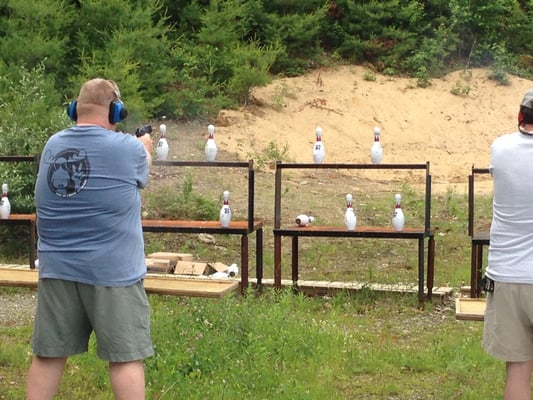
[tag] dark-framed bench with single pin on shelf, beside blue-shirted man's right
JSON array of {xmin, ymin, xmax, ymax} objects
[{"xmin": 142, "ymin": 160, "xmax": 263, "ymax": 293}]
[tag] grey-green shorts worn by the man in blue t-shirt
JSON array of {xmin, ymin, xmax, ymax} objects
[{"xmin": 32, "ymin": 279, "xmax": 154, "ymax": 362}]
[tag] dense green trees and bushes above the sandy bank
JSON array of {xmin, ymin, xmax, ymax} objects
[{"xmin": 0, "ymin": 0, "xmax": 533, "ymax": 212}]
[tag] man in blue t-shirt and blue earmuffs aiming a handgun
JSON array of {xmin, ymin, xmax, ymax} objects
[{"xmin": 27, "ymin": 78, "xmax": 153, "ymax": 400}]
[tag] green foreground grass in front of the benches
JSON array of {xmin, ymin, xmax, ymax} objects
[{"xmin": 0, "ymin": 290, "xmax": 504, "ymax": 400}]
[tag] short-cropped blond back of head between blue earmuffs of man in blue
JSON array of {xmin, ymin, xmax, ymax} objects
[{"xmin": 76, "ymin": 78, "xmax": 120, "ymax": 117}]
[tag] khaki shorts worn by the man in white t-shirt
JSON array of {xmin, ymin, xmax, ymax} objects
[{"xmin": 483, "ymin": 282, "xmax": 533, "ymax": 362}]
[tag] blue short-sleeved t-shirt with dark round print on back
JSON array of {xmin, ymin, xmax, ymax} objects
[{"xmin": 35, "ymin": 126, "xmax": 149, "ymax": 286}]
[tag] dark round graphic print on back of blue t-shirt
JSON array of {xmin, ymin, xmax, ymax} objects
[{"xmin": 45, "ymin": 149, "xmax": 91, "ymax": 197}]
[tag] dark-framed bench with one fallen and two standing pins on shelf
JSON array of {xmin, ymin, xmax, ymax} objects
[{"xmin": 274, "ymin": 161, "xmax": 435, "ymax": 304}]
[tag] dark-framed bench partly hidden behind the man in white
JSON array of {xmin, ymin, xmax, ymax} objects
[{"xmin": 468, "ymin": 165, "xmax": 490, "ymax": 298}]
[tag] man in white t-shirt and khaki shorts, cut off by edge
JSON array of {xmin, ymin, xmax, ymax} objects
[{"xmin": 483, "ymin": 88, "xmax": 533, "ymax": 400}]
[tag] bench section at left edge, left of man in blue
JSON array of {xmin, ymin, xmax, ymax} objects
[{"xmin": 0, "ymin": 154, "xmax": 40, "ymax": 269}]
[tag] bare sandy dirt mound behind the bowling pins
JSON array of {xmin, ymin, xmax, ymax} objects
[{"xmin": 212, "ymin": 66, "xmax": 533, "ymax": 192}]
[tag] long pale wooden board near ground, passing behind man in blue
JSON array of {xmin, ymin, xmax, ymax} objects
[{"xmin": 0, "ymin": 268, "xmax": 239, "ymax": 298}]
